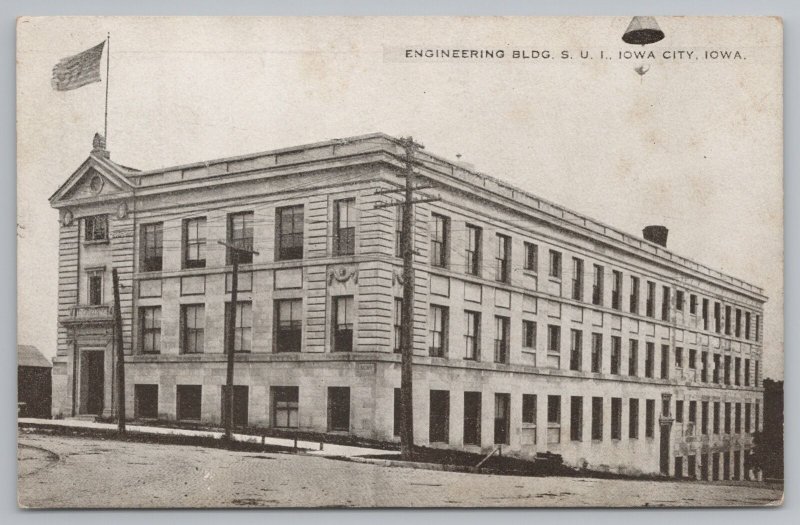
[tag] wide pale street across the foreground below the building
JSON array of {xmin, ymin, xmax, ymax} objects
[{"xmin": 17, "ymin": 433, "xmax": 783, "ymax": 508}]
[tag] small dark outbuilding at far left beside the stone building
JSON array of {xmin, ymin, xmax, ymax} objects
[{"xmin": 17, "ymin": 345, "xmax": 53, "ymax": 418}]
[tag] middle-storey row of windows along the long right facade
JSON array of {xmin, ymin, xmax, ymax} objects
[{"xmin": 422, "ymin": 299, "xmax": 759, "ymax": 386}]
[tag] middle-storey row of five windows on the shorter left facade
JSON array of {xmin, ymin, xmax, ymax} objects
[{"xmin": 139, "ymin": 296, "xmax": 355, "ymax": 354}]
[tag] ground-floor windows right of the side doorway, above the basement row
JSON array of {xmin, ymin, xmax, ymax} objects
[{"xmin": 675, "ymin": 399, "xmax": 761, "ymax": 436}]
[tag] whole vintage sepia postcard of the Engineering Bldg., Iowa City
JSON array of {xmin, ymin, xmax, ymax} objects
[{"xmin": 17, "ymin": 17, "xmax": 784, "ymax": 508}]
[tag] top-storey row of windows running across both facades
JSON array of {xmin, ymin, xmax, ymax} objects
[{"xmin": 85, "ymin": 207, "xmax": 760, "ymax": 341}]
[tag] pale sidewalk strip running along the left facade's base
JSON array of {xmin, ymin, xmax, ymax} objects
[{"xmin": 17, "ymin": 417, "xmax": 400, "ymax": 458}]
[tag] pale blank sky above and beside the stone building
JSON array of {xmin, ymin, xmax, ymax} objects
[{"xmin": 17, "ymin": 17, "xmax": 783, "ymax": 379}]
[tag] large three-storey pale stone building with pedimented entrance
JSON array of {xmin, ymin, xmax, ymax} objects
[{"xmin": 51, "ymin": 134, "xmax": 766, "ymax": 479}]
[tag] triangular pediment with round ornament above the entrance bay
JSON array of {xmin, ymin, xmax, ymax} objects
[{"xmin": 50, "ymin": 155, "xmax": 133, "ymax": 205}]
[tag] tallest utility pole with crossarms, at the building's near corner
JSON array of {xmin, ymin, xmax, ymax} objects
[{"xmin": 375, "ymin": 137, "xmax": 439, "ymax": 460}]
